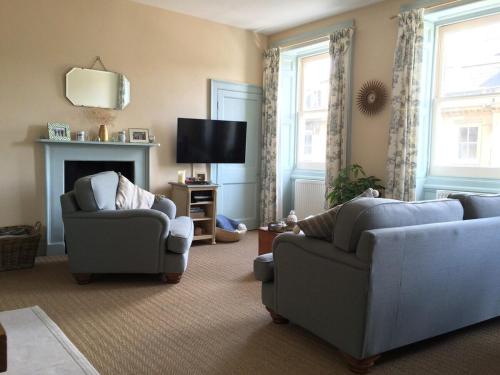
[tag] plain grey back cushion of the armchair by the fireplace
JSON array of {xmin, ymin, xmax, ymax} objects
[{"xmin": 74, "ymin": 172, "xmax": 118, "ymax": 212}]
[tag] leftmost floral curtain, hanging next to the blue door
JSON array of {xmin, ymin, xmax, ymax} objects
[{"xmin": 260, "ymin": 48, "xmax": 280, "ymax": 225}]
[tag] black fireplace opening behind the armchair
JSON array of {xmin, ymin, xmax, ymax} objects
[{"xmin": 64, "ymin": 160, "xmax": 135, "ymax": 193}]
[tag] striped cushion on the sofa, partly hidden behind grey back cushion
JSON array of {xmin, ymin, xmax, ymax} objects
[{"xmin": 297, "ymin": 188, "xmax": 379, "ymax": 242}]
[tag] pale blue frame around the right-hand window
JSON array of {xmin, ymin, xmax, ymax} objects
[{"xmin": 418, "ymin": 0, "xmax": 500, "ymax": 200}]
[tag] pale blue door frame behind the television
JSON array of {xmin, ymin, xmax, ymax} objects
[{"xmin": 209, "ymin": 79, "xmax": 263, "ymax": 225}]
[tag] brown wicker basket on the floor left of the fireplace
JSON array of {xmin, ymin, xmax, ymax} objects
[{"xmin": 0, "ymin": 222, "xmax": 40, "ymax": 271}]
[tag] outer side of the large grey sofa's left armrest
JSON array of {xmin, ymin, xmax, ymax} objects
[{"xmin": 266, "ymin": 234, "xmax": 370, "ymax": 358}]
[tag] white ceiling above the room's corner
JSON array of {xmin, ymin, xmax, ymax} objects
[{"xmin": 133, "ymin": 0, "xmax": 382, "ymax": 35}]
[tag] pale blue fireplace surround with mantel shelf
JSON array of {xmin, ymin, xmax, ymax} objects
[{"xmin": 37, "ymin": 139, "xmax": 159, "ymax": 255}]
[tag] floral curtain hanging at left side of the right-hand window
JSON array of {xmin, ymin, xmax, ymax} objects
[{"xmin": 385, "ymin": 9, "xmax": 424, "ymax": 201}]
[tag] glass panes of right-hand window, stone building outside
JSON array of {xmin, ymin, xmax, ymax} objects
[{"xmin": 431, "ymin": 15, "xmax": 500, "ymax": 178}]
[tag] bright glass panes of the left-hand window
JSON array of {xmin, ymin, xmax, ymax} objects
[{"xmin": 296, "ymin": 53, "xmax": 330, "ymax": 170}]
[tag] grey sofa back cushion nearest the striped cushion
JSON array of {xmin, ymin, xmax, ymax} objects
[{"xmin": 333, "ymin": 198, "xmax": 463, "ymax": 252}]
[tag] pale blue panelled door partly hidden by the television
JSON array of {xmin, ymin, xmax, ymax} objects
[{"xmin": 211, "ymin": 80, "xmax": 262, "ymax": 229}]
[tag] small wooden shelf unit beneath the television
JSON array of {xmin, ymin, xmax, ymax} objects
[{"xmin": 169, "ymin": 182, "xmax": 219, "ymax": 245}]
